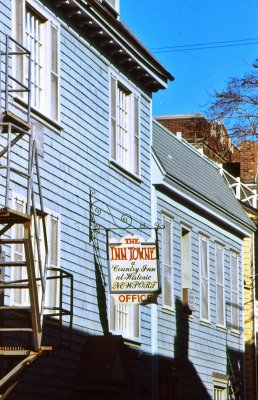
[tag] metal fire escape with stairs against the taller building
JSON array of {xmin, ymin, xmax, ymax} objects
[{"xmin": 0, "ymin": 36, "xmax": 72, "ymax": 399}]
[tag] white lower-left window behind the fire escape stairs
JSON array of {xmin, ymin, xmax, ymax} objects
[{"xmin": 11, "ymin": 196, "xmax": 60, "ymax": 307}]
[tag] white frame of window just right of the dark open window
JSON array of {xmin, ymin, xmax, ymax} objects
[{"xmin": 199, "ymin": 234, "xmax": 210, "ymax": 322}]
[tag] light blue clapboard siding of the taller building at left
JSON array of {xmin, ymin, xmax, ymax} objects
[{"xmin": 0, "ymin": 1, "xmax": 155, "ymax": 400}]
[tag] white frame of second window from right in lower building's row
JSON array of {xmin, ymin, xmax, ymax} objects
[{"xmin": 215, "ymin": 243, "xmax": 226, "ymax": 328}]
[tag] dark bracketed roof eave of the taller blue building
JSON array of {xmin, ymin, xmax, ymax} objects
[{"xmin": 51, "ymin": 0, "xmax": 174, "ymax": 92}]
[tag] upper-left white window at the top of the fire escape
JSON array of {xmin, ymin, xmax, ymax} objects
[{"xmin": 12, "ymin": 0, "xmax": 59, "ymax": 120}]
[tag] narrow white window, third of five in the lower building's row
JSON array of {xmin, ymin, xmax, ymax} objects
[{"xmin": 199, "ymin": 236, "xmax": 210, "ymax": 320}]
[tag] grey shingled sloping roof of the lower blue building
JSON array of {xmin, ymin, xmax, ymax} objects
[{"xmin": 153, "ymin": 120, "xmax": 255, "ymax": 235}]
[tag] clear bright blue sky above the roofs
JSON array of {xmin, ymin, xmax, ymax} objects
[{"xmin": 120, "ymin": 0, "xmax": 258, "ymax": 119}]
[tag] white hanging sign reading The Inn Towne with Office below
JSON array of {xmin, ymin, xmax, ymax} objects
[{"xmin": 109, "ymin": 236, "xmax": 160, "ymax": 304}]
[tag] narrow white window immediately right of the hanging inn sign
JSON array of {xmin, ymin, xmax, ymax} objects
[{"xmin": 162, "ymin": 215, "xmax": 173, "ymax": 308}]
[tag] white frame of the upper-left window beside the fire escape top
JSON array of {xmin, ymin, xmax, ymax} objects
[{"xmin": 12, "ymin": 0, "xmax": 60, "ymax": 122}]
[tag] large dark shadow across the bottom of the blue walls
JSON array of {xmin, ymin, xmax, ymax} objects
[{"xmin": 3, "ymin": 300, "xmax": 246, "ymax": 400}]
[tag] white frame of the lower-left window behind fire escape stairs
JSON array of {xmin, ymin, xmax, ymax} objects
[{"xmin": 10, "ymin": 193, "xmax": 61, "ymax": 313}]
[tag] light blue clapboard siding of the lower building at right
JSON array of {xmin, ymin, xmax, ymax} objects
[{"xmin": 157, "ymin": 192, "xmax": 243, "ymax": 395}]
